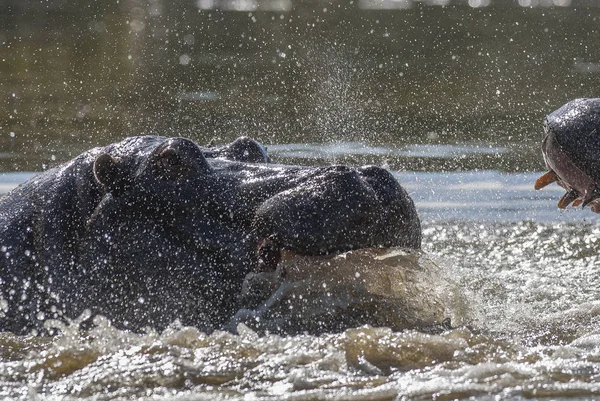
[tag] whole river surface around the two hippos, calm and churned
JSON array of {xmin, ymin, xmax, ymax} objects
[{"xmin": 0, "ymin": 0, "xmax": 600, "ymax": 401}]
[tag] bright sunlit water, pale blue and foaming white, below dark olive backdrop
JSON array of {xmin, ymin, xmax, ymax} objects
[{"xmin": 0, "ymin": 143, "xmax": 600, "ymax": 400}]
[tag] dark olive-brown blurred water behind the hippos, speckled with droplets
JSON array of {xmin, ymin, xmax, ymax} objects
[{"xmin": 0, "ymin": 0, "xmax": 600, "ymax": 172}]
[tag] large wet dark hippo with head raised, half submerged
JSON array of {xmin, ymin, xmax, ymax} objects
[{"xmin": 0, "ymin": 136, "xmax": 421, "ymax": 334}]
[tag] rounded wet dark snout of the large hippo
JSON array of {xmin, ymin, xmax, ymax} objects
[{"xmin": 253, "ymin": 166, "xmax": 421, "ymax": 255}]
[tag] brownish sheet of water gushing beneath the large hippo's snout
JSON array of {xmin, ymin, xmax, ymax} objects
[{"xmin": 232, "ymin": 248, "xmax": 470, "ymax": 334}]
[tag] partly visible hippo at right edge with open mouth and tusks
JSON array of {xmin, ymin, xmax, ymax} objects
[{"xmin": 535, "ymin": 99, "xmax": 600, "ymax": 213}]
